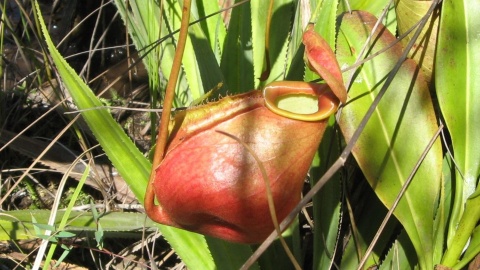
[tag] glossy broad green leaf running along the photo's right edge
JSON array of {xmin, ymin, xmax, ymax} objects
[{"xmin": 435, "ymin": 0, "xmax": 480, "ymax": 266}]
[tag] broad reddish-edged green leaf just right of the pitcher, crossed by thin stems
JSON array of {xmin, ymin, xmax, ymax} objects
[{"xmin": 337, "ymin": 12, "xmax": 442, "ymax": 269}]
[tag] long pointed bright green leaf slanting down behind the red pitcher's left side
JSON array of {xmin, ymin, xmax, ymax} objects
[{"xmin": 35, "ymin": 2, "xmax": 214, "ymax": 269}]
